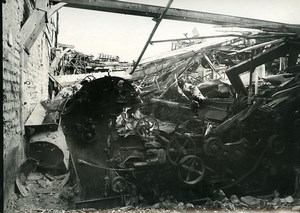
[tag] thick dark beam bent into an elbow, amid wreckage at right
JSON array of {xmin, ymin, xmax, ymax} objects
[{"xmin": 226, "ymin": 44, "xmax": 288, "ymax": 95}]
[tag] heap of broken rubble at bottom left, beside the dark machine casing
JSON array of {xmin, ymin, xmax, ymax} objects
[{"xmin": 7, "ymin": 172, "xmax": 76, "ymax": 212}]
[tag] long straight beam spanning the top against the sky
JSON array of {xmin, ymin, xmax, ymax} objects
[{"xmin": 50, "ymin": 0, "xmax": 300, "ymax": 33}]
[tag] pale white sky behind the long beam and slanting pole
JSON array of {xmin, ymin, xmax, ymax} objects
[{"xmin": 58, "ymin": 0, "xmax": 300, "ymax": 62}]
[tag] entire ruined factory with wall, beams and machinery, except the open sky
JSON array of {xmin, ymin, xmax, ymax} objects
[{"xmin": 2, "ymin": 0, "xmax": 300, "ymax": 212}]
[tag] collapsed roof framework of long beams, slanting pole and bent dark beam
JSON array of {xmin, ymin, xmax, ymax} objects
[{"xmin": 50, "ymin": 0, "xmax": 300, "ymax": 94}]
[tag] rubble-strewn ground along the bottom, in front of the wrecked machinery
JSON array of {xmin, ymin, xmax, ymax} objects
[{"xmin": 6, "ymin": 172, "xmax": 300, "ymax": 213}]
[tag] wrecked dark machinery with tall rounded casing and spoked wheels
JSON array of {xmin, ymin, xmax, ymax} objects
[{"xmin": 61, "ymin": 76, "xmax": 300, "ymax": 206}]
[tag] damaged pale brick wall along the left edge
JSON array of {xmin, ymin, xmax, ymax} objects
[{"xmin": 2, "ymin": 0, "xmax": 56, "ymax": 206}]
